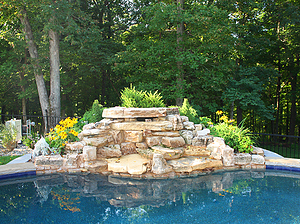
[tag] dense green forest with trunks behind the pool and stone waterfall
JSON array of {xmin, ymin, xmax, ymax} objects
[{"xmin": 0, "ymin": 0, "xmax": 300, "ymax": 135}]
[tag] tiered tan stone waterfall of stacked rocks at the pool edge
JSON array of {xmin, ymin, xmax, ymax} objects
[{"xmin": 35, "ymin": 107, "xmax": 265, "ymax": 178}]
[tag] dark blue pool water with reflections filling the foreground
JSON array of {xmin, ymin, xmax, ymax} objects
[{"xmin": 0, "ymin": 171, "xmax": 300, "ymax": 224}]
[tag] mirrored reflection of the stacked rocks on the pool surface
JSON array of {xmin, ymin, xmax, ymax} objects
[{"xmin": 34, "ymin": 171, "xmax": 258, "ymax": 208}]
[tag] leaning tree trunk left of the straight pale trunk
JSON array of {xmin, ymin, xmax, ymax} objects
[{"xmin": 20, "ymin": 8, "xmax": 49, "ymax": 131}]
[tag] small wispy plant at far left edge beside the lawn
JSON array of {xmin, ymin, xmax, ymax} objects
[{"xmin": 0, "ymin": 124, "xmax": 17, "ymax": 150}]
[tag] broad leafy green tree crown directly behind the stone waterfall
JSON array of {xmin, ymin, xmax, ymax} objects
[{"xmin": 113, "ymin": 1, "xmax": 233, "ymax": 107}]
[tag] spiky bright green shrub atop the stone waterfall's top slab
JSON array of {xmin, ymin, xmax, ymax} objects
[{"xmin": 121, "ymin": 86, "xmax": 165, "ymax": 108}]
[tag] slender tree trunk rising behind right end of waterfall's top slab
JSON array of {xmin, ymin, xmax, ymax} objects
[{"xmin": 176, "ymin": 0, "xmax": 184, "ymax": 106}]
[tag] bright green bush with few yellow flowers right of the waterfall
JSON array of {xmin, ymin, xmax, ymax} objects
[{"xmin": 211, "ymin": 111, "xmax": 255, "ymax": 153}]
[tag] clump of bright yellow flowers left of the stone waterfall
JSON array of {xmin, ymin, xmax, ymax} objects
[{"xmin": 45, "ymin": 117, "xmax": 82, "ymax": 154}]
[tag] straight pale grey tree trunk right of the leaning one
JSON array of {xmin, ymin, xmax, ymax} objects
[{"xmin": 49, "ymin": 29, "xmax": 61, "ymax": 127}]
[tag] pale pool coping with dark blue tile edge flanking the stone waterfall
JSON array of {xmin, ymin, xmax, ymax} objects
[{"xmin": 0, "ymin": 150, "xmax": 300, "ymax": 180}]
